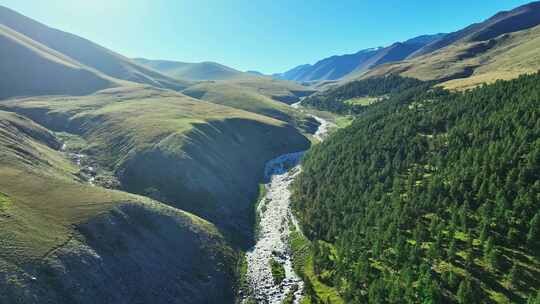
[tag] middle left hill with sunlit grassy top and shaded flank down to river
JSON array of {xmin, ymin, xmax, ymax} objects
[{"xmin": 0, "ymin": 87, "xmax": 309, "ymax": 243}]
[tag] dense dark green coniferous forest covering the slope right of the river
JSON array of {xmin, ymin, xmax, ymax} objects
[{"xmin": 293, "ymin": 73, "xmax": 540, "ymax": 304}]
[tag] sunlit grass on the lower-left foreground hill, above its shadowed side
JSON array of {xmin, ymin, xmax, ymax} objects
[{"xmin": 0, "ymin": 111, "xmax": 221, "ymax": 271}]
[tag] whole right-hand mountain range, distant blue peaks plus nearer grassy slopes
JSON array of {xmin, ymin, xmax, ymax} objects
[{"xmin": 273, "ymin": 1, "xmax": 540, "ymax": 87}]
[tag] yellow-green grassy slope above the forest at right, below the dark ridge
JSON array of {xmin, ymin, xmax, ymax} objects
[{"xmin": 364, "ymin": 26, "xmax": 540, "ymax": 89}]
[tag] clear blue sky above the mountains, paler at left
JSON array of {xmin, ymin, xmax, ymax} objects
[{"xmin": 0, "ymin": 0, "xmax": 529, "ymax": 73}]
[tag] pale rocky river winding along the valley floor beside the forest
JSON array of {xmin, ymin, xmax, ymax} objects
[{"xmin": 246, "ymin": 116, "xmax": 332, "ymax": 304}]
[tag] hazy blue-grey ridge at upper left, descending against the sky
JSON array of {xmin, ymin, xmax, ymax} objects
[{"xmin": 0, "ymin": 6, "xmax": 188, "ymax": 94}]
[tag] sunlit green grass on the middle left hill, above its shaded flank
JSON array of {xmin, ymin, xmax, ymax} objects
[{"xmin": 4, "ymin": 87, "xmax": 284, "ymax": 167}]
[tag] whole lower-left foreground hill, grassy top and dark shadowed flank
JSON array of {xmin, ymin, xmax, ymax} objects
[{"xmin": 0, "ymin": 111, "xmax": 233, "ymax": 303}]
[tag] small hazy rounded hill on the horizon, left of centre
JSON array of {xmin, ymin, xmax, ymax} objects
[{"xmin": 134, "ymin": 58, "xmax": 246, "ymax": 81}]
